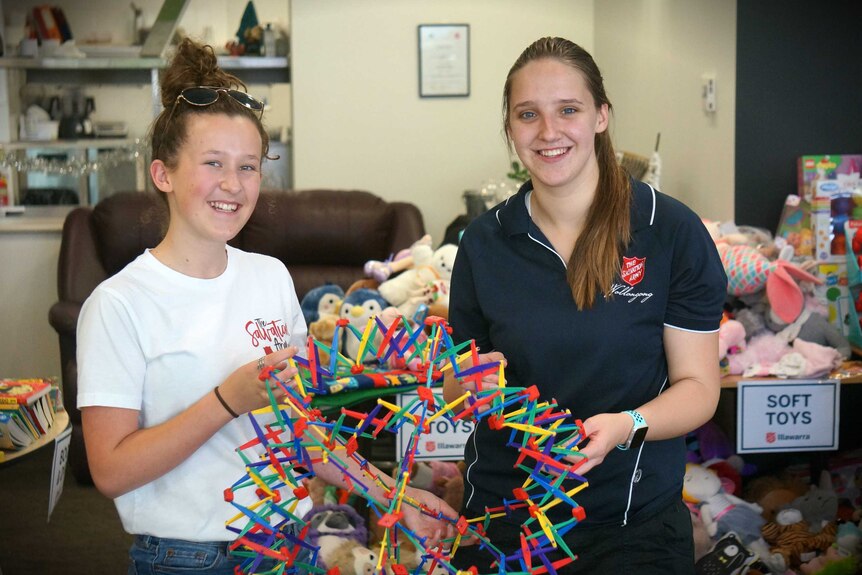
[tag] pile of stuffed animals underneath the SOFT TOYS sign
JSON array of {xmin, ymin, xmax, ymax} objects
[{"xmin": 696, "ymin": 464, "xmax": 862, "ymax": 575}]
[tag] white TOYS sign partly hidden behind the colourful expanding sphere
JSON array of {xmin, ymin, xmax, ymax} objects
[{"xmin": 395, "ymin": 389, "xmax": 476, "ymax": 461}]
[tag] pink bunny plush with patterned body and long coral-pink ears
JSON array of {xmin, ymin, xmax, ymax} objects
[{"xmin": 716, "ymin": 242, "xmax": 823, "ymax": 323}]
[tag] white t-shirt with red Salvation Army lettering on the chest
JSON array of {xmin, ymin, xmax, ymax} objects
[{"xmin": 77, "ymin": 246, "xmax": 311, "ymax": 541}]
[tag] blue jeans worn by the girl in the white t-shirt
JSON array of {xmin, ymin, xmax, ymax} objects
[{"xmin": 128, "ymin": 535, "xmax": 318, "ymax": 575}]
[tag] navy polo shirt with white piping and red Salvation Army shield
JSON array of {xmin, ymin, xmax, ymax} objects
[{"xmin": 449, "ymin": 181, "xmax": 727, "ymax": 527}]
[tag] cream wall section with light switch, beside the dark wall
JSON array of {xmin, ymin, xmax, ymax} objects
[{"xmin": 594, "ymin": 0, "xmax": 736, "ymax": 220}]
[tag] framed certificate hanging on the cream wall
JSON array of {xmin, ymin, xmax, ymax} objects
[{"xmin": 418, "ymin": 24, "xmax": 470, "ymax": 98}]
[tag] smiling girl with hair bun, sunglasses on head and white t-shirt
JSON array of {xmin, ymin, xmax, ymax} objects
[{"xmin": 78, "ymin": 40, "xmax": 455, "ymax": 575}]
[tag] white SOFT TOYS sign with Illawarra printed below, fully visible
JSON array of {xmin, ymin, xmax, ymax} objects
[{"xmin": 736, "ymin": 380, "xmax": 841, "ymax": 453}]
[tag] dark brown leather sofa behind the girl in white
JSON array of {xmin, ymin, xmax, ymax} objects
[{"xmin": 48, "ymin": 190, "xmax": 425, "ymax": 483}]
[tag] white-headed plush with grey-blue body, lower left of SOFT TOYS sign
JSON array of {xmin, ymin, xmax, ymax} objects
[{"xmin": 682, "ymin": 463, "xmax": 787, "ymax": 573}]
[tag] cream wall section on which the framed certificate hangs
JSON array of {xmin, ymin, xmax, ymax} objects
[{"xmin": 291, "ymin": 0, "xmax": 598, "ymax": 241}]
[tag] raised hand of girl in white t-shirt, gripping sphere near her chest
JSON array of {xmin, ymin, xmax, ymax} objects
[{"xmin": 218, "ymin": 346, "xmax": 298, "ymax": 414}]
